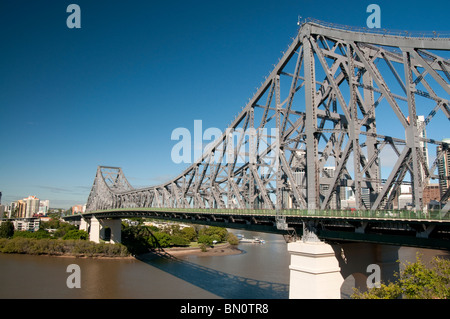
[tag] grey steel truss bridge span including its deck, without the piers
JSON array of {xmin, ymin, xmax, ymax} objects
[{"xmin": 66, "ymin": 21, "xmax": 450, "ymax": 248}]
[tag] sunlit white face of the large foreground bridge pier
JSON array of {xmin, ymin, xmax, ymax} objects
[{"xmin": 288, "ymin": 236, "xmax": 344, "ymax": 299}]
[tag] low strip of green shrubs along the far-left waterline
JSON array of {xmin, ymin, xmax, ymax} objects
[{"xmin": 0, "ymin": 237, "xmax": 130, "ymax": 257}]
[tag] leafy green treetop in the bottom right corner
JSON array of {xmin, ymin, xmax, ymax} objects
[{"xmin": 352, "ymin": 254, "xmax": 450, "ymax": 299}]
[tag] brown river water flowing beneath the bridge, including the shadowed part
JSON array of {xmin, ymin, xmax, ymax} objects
[{"xmin": 0, "ymin": 230, "xmax": 449, "ymax": 299}]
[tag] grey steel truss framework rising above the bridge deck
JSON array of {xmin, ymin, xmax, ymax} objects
[{"xmin": 87, "ymin": 23, "xmax": 450, "ymax": 211}]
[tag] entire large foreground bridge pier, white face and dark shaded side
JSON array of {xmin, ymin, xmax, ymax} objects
[{"xmin": 288, "ymin": 223, "xmax": 400, "ymax": 299}]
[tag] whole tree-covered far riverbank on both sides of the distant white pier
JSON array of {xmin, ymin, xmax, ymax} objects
[{"xmin": 0, "ymin": 220, "xmax": 239, "ymax": 257}]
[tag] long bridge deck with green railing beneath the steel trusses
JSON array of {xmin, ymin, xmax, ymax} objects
[{"xmin": 64, "ymin": 207, "xmax": 450, "ymax": 249}]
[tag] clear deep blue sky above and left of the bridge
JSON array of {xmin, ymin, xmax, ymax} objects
[{"xmin": 0, "ymin": 0, "xmax": 450, "ymax": 208}]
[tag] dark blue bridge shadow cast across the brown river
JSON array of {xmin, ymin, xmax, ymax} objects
[{"xmin": 136, "ymin": 250, "xmax": 289, "ymax": 299}]
